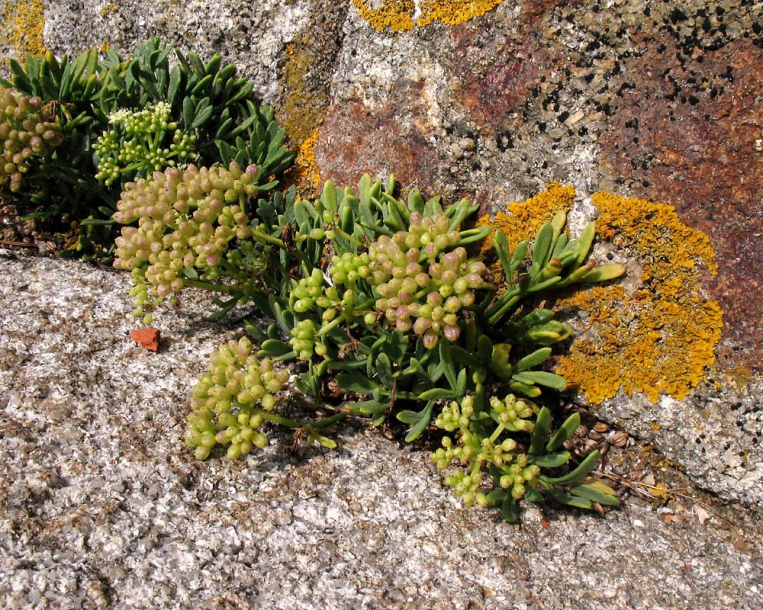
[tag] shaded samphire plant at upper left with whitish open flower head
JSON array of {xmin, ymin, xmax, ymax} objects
[{"xmin": 0, "ymin": 38, "xmax": 294, "ymax": 256}]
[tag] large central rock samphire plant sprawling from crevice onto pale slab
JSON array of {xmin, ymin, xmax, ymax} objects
[{"xmin": 115, "ymin": 167, "xmax": 624, "ymax": 521}]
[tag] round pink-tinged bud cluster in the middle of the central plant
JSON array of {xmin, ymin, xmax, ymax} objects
[{"xmin": 360, "ymin": 212, "xmax": 487, "ymax": 349}]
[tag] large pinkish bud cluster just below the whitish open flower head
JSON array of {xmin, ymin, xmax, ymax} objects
[{"xmin": 114, "ymin": 162, "xmax": 258, "ymax": 300}]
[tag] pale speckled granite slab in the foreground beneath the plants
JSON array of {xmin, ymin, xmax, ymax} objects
[{"xmin": 0, "ymin": 258, "xmax": 763, "ymax": 610}]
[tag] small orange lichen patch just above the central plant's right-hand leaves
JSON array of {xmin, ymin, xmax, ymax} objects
[{"xmin": 476, "ymin": 182, "xmax": 575, "ymax": 252}]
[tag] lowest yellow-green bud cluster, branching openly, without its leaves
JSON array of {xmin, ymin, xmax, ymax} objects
[{"xmin": 432, "ymin": 394, "xmax": 540, "ymax": 506}]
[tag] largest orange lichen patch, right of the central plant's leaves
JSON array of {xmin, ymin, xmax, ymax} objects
[{"xmin": 556, "ymin": 193, "xmax": 723, "ymax": 404}]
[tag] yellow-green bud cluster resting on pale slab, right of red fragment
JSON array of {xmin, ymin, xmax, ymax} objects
[{"xmin": 185, "ymin": 337, "xmax": 289, "ymax": 460}]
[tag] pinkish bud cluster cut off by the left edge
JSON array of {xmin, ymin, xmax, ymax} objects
[{"xmin": 0, "ymin": 89, "xmax": 64, "ymax": 193}]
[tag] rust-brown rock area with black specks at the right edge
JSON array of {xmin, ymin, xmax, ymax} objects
[{"xmin": 601, "ymin": 41, "xmax": 763, "ymax": 368}]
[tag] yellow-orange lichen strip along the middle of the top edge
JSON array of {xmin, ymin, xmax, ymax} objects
[{"xmin": 352, "ymin": 0, "xmax": 503, "ymax": 32}]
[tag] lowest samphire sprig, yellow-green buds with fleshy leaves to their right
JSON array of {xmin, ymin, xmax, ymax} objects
[{"xmin": 432, "ymin": 394, "xmax": 618, "ymax": 522}]
